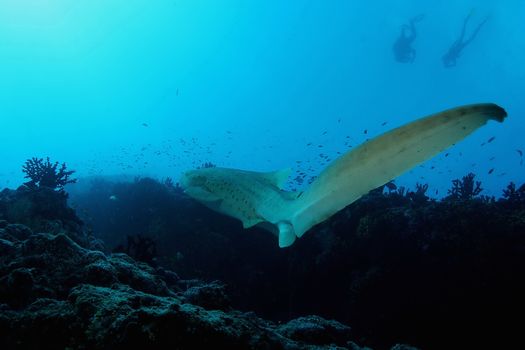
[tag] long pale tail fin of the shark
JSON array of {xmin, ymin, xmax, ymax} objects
[{"xmin": 290, "ymin": 103, "xmax": 507, "ymax": 238}]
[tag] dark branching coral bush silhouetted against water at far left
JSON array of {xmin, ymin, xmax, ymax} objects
[{"xmin": 22, "ymin": 157, "xmax": 77, "ymax": 191}]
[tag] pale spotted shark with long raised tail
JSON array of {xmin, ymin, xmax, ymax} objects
[{"xmin": 180, "ymin": 103, "xmax": 507, "ymax": 248}]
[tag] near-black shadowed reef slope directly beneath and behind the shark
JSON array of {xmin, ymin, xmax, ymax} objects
[{"xmin": 66, "ymin": 174, "xmax": 525, "ymax": 349}]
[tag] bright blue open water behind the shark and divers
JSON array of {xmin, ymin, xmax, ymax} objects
[{"xmin": 0, "ymin": 0, "xmax": 525, "ymax": 196}]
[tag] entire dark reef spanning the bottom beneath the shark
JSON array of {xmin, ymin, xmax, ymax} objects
[{"xmin": 0, "ymin": 165, "xmax": 525, "ymax": 349}]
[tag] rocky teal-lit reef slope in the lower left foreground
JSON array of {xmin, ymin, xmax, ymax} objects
[{"xmin": 0, "ymin": 179, "xmax": 392, "ymax": 350}]
